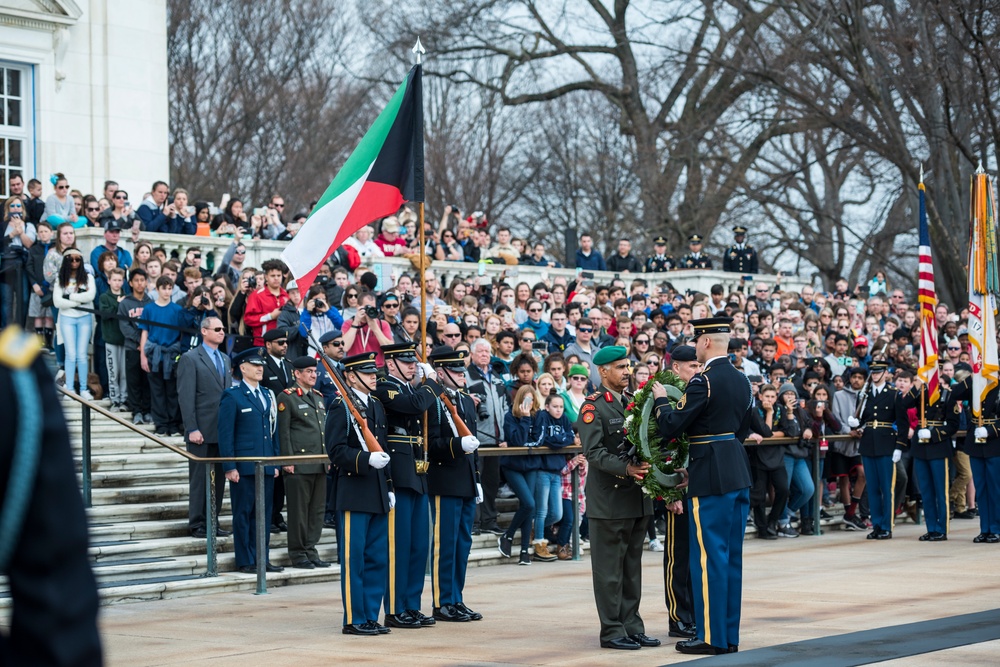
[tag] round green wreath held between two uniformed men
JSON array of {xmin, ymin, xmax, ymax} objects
[{"xmin": 625, "ymin": 370, "xmax": 690, "ymax": 503}]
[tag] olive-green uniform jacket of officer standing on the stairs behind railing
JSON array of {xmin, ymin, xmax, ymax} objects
[{"xmin": 277, "ymin": 385, "xmax": 326, "ymax": 475}]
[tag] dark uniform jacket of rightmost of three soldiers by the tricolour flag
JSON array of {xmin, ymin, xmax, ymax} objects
[{"xmin": 427, "ymin": 393, "xmax": 479, "ymax": 498}]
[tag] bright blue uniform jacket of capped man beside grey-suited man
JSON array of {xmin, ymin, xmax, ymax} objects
[{"xmin": 219, "ymin": 382, "xmax": 281, "ymax": 476}]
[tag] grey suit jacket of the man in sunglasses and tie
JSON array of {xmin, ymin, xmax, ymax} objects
[{"xmin": 177, "ymin": 345, "xmax": 232, "ymax": 443}]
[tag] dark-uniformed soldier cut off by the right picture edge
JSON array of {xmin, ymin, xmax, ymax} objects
[{"xmin": 952, "ymin": 376, "xmax": 1000, "ymax": 544}]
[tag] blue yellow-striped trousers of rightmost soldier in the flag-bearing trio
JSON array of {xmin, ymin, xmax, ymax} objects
[{"xmin": 431, "ymin": 496, "xmax": 476, "ymax": 608}]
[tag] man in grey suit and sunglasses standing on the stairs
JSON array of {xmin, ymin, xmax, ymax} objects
[{"xmin": 177, "ymin": 317, "xmax": 232, "ymax": 538}]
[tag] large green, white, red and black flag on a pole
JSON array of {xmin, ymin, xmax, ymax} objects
[{"xmin": 281, "ymin": 65, "xmax": 424, "ymax": 294}]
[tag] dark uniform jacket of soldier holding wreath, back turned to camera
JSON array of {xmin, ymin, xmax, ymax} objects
[{"xmin": 654, "ymin": 357, "xmax": 752, "ymax": 496}]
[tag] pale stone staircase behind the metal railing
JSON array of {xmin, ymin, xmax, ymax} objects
[{"xmin": 0, "ymin": 397, "xmax": 556, "ymax": 609}]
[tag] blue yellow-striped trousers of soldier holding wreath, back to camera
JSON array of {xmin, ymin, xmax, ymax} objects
[{"xmin": 688, "ymin": 488, "xmax": 750, "ymax": 648}]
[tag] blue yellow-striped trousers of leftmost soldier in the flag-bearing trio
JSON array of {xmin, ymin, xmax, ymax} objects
[{"xmin": 338, "ymin": 511, "xmax": 389, "ymax": 625}]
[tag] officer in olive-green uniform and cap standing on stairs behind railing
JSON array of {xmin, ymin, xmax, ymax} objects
[{"xmin": 278, "ymin": 358, "xmax": 330, "ymax": 570}]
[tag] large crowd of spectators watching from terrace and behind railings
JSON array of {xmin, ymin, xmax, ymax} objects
[{"xmin": 0, "ymin": 174, "xmax": 975, "ymax": 561}]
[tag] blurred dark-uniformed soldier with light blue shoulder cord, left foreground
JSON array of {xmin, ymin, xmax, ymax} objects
[{"xmin": 0, "ymin": 326, "xmax": 102, "ymax": 667}]
